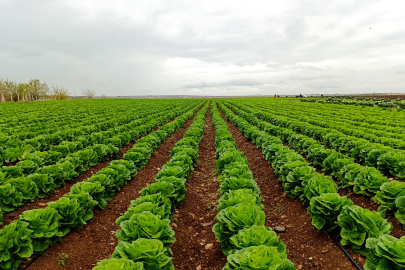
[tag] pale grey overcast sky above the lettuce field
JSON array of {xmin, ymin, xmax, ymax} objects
[{"xmin": 0, "ymin": 0, "xmax": 405, "ymax": 95}]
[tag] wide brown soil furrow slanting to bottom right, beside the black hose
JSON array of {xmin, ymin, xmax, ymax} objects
[{"xmin": 218, "ymin": 108, "xmax": 356, "ymax": 270}]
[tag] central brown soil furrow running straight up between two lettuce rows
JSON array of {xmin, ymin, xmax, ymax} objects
[{"xmin": 172, "ymin": 105, "xmax": 226, "ymax": 269}]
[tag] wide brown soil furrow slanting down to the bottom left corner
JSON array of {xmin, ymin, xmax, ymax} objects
[{"xmin": 27, "ymin": 108, "xmax": 201, "ymax": 270}]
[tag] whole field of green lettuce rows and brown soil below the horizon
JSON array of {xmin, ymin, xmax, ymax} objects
[{"xmin": 0, "ymin": 98, "xmax": 405, "ymax": 270}]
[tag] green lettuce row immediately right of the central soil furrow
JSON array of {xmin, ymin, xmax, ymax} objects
[{"xmin": 212, "ymin": 104, "xmax": 295, "ymax": 270}]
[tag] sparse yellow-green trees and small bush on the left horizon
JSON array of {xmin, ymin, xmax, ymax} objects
[{"xmin": 0, "ymin": 78, "xmax": 96, "ymax": 102}]
